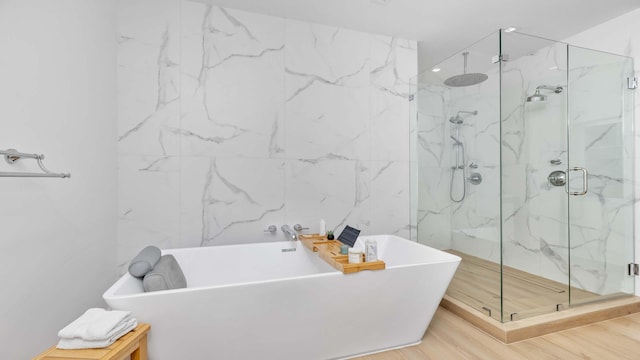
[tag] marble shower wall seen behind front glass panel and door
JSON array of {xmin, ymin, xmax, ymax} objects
[{"xmin": 502, "ymin": 36, "xmax": 634, "ymax": 294}]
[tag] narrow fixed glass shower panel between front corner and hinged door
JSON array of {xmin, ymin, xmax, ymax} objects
[{"xmin": 500, "ymin": 32, "xmax": 569, "ymax": 322}]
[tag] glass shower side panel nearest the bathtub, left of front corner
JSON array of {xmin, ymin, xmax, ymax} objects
[{"xmin": 414, "ymin": 31, "xmax": 502, "ymax": 321}]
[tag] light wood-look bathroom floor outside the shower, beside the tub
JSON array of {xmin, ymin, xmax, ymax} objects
[{"xmin": 357, "ymin": 307, "xmax": 640, "ymax": 360}]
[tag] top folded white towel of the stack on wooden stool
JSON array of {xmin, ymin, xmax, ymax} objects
[{"xmin": 58, "ymin": 308, "xmax": 135, "ymax": 341}]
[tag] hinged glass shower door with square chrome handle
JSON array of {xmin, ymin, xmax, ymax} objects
[{"xmin": 567, "ymin": 46, "xmax": 634, "ymax": 305}]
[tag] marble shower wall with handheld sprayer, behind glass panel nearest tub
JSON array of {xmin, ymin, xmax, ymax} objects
[{"xmin": 417, "ymin": 49, "xmax": 500, "ymax": 261}]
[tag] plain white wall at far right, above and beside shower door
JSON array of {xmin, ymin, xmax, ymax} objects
[{"xmin": 565, "ymin": 9, "xmax": 640, "ymax": 296}]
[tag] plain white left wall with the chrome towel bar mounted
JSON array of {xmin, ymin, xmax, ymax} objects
[{"xmin": 0, "ymin": 0, "xmax": 116, "ymax": 359}]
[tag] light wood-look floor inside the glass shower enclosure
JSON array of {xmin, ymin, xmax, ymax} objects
[{"xmin": 446, "ymin": 250, "xmax": 620, "ymax": 322}]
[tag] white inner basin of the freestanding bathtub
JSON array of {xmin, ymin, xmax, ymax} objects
[{"xmin": 105, "ymin": 235, "xmax": 459, "ymax": 297}]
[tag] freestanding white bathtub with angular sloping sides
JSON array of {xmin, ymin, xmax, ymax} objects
[{"xmin": 103, "ymin": 235, "xmax": 460, "ymax": 360}]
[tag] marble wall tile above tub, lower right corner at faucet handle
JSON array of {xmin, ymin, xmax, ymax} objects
[{"xmin": 180, "ymin": 157, "xmax": 285, "ymax": 246}]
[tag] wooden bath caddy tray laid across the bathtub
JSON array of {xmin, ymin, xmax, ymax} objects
[{"xmin": 299, "ymin": 235, "xmax": 386, "ymax": 274}]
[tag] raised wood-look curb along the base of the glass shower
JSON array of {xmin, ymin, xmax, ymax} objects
[{"xmin": 440, "ymin": 295, "xmax": 640, "ymax": 344}]
